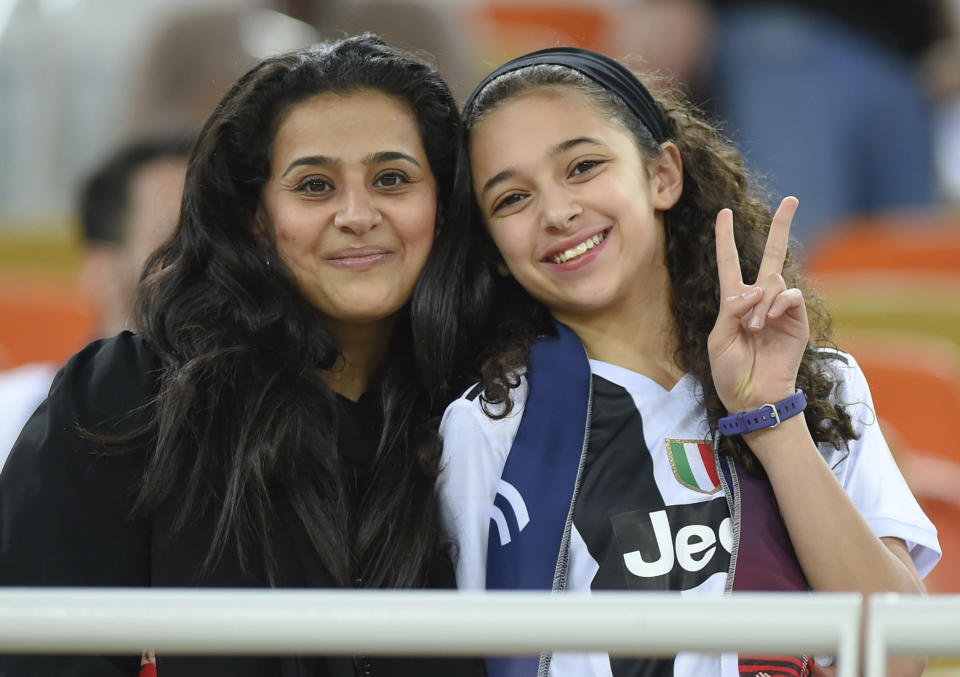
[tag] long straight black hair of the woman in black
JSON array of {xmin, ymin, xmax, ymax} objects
[{"xmin": 126, "ymin": 36, "xmax": 459, "ymax": 587}]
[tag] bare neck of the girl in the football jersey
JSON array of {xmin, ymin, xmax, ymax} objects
[{"xmin": 554, "ymin": 290, "xmax": 685, "ymax": 390}]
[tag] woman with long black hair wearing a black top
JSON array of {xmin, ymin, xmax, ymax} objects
[{"xmin": 0, "ymin": 36, "xmax": 476, "ymax": 677}]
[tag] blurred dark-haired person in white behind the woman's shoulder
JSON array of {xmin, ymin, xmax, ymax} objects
[{"xmin": 0, "ymin": 133, "xmax": 191, "ymax": 467}]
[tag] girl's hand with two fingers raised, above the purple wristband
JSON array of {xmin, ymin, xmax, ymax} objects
[{"xmin": 707, "ymin": 197, "xmax": 810, "ymax": 413}]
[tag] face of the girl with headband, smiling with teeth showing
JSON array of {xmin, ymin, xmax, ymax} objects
[{"xmin": 470, "ymin": 86, "xmax": 682, "ymax": 322}]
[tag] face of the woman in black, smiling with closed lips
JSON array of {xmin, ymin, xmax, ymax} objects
[{"xmin": 263, "ymin": 91, "xmax": 437, "ymax": 332}]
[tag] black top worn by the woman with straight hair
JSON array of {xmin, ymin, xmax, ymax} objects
[{"xmin": 0, "ymin": 332, "xmax": 479, "ymax": 677}]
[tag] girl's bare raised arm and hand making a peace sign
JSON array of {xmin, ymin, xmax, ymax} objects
[{"xmin": 708, "ymin": 197, "xmax": 925, "ymax": 675}]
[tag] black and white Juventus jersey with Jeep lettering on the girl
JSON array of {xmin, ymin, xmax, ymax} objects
[{"xmin": 438, "ymin": 354, "xmax": 940, "ymax": 677}]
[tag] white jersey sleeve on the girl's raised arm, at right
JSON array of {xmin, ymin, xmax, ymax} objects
[{"xmin": 820, "ymin": 353, "xmax": 941, "ymax": 576}]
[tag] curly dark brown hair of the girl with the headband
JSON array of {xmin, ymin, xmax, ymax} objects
[{"xmin": 448, "ymin": 65, "xmax": 855, "ymax": 473}]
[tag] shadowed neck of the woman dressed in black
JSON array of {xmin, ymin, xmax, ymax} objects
[{"xmin": 323, "ymin": 317, "xmax": 395, "ymax": 402}]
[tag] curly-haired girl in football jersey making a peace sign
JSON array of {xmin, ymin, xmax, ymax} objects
[{"xmin": 440, "ymin": 48, "xmax": 939, "ymax": 677}]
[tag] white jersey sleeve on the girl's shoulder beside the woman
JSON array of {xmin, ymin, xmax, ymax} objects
[{"xmin": 437, "ymin": 382, "xmax": 526, "ymax": 590}]
